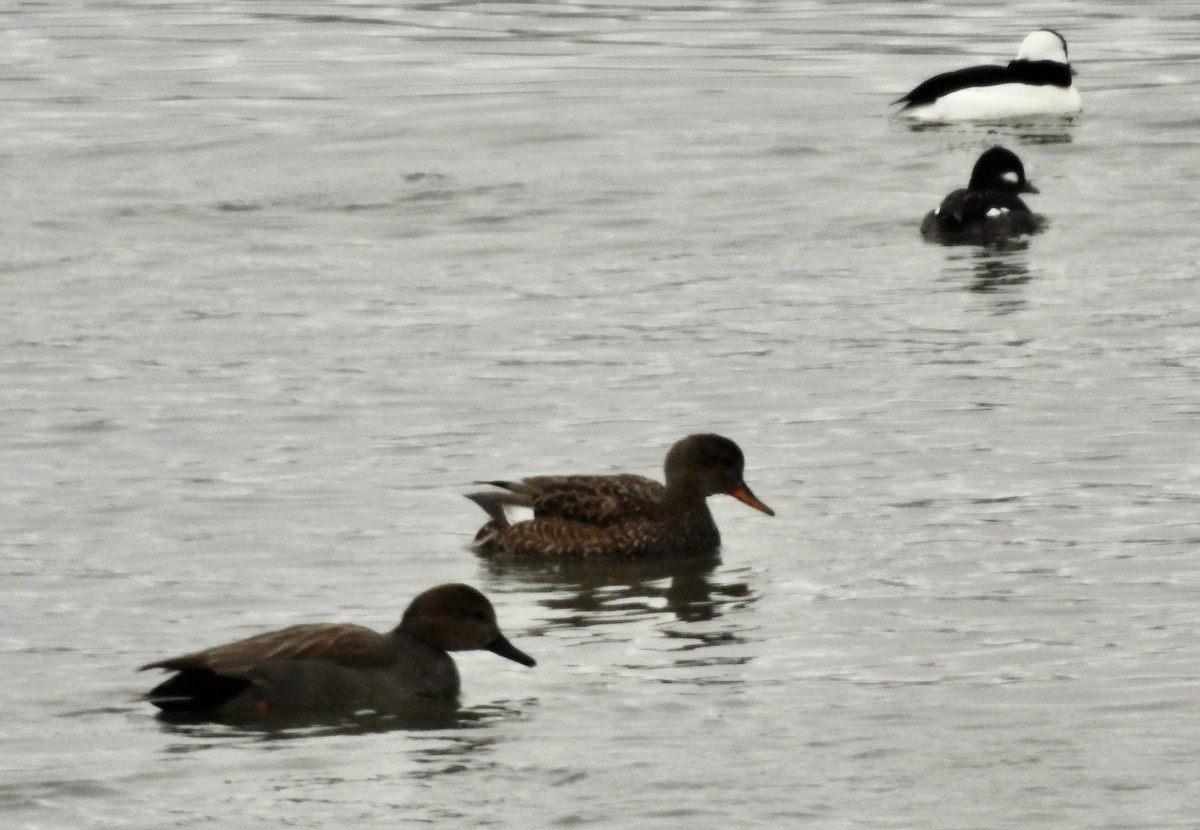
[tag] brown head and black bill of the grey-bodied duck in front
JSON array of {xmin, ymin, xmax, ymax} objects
[{"xmin": 400, "ymin": 583, "xmax": 536, "ymax": 666}]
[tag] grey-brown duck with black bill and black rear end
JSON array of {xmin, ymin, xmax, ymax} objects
[{"xmin": 142, "ymin": 583, "xmax": 536, "ymax": 716}]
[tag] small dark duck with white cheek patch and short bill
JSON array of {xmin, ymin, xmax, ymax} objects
[{"xmin": 920, "ymin": 146, "xmax": 1043, "ymax": 245}]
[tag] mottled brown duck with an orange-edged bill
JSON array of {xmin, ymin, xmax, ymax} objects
[{"xmin": 467, "ymin": 433, "xmax": 775, "ymax": 559}]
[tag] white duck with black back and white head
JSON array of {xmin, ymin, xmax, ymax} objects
[{"xmin": 892, "ymin": 29, "xmax": 1082, "ymax": 122}]
